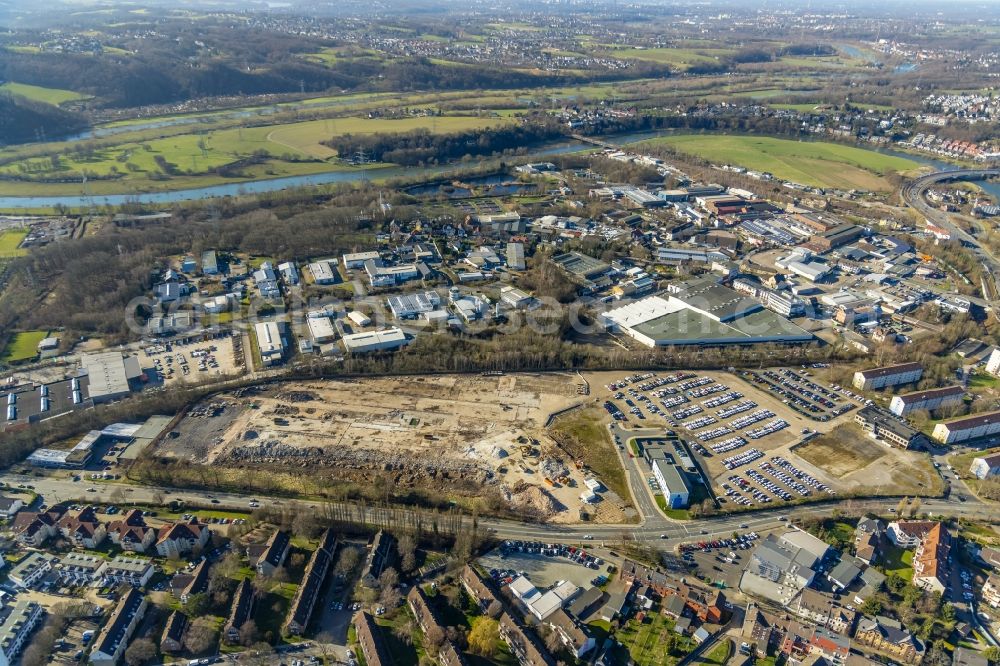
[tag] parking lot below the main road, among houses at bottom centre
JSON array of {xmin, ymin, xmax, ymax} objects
[{"xmin": 479, "ymin": 541, "xmax": 609, "ymax": 589}]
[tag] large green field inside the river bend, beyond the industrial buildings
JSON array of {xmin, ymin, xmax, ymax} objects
[{"xmin": 651, "ymin": 134, "xmax": 919, "ymax": 191}]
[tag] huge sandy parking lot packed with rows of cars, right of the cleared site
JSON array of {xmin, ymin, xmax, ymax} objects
[{"xmin": 604, "ymin": 368, "xmax": 864, "ymax": 507}]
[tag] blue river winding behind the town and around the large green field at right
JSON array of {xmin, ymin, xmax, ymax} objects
[{"xmin": 0, "ymin": 131, "xmax": 1000, "ymax": 210}]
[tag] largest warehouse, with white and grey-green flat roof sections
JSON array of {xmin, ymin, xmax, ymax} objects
[{"xmin": 601, "ymin": 278, "xmax": 813, "ymax": 347}]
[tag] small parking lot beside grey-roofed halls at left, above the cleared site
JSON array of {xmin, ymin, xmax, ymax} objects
[{"xmin": 140, "ymin": 336, "xmax": 245, "ymax": 385}]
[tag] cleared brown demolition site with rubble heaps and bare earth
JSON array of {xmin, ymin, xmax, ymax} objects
[{"xmin": 155, "ymin": 373, "xmax": 625, "ymax": 522}]
